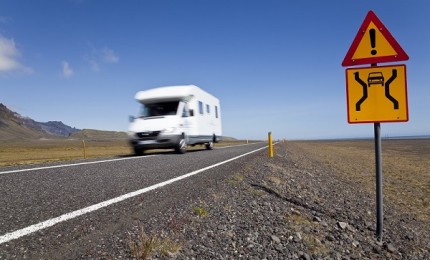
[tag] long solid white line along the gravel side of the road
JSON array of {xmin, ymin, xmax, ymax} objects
[{"xmin": 0, "ymin": 146, "xmax": 267, "ymax": 244}]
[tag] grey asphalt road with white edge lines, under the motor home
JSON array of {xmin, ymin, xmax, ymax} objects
[{"xmin": 0, "ymin": 143, "xmax": 266, "ymax": 259}]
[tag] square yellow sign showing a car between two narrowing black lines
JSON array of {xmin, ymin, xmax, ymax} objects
[{"xmin": 346, "ymin": 65, "xmax": 409, "ymax": 124}]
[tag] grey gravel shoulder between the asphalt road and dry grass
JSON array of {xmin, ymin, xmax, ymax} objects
[{"xmin": 81, "ymin": 142, "xmax": 430, "ymax": 259}]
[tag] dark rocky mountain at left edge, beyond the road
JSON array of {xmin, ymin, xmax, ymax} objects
[{"xmin": 0, "ymin": 103, "xmax": 80, "ymax": 140}]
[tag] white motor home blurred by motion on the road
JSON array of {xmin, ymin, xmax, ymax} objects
[{"xmin": 129, "ymin": 85, "xmax": 222, "ymax": 154}]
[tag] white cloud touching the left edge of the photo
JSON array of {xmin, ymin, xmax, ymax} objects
[{"xmin": 0, "ymin": 35, "xmax": 33, "ymax": 73}]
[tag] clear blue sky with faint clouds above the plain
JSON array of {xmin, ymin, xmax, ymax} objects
[{"xmin": 0, "ymin": 0, "xmax": 430, "ymax": 140}]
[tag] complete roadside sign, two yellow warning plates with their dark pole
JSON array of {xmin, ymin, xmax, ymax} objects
[{"xmin": 342, "ymin": 11, "xmax": 409, "ymax": 241}]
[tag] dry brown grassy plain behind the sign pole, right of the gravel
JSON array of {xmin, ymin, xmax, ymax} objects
[{"xmin": 291, "ymin": 139, "xmax": 430, "ymax": 223}]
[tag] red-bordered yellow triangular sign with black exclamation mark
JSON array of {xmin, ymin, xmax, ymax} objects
[{"xmin": 342, "ymin": 11, "xmax": 409, "ymax": 67}]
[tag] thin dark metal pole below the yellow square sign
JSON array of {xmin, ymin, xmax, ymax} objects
[{"xmin": 374, "ymin": 123, "xmax": 384, "ymax": 241}]
